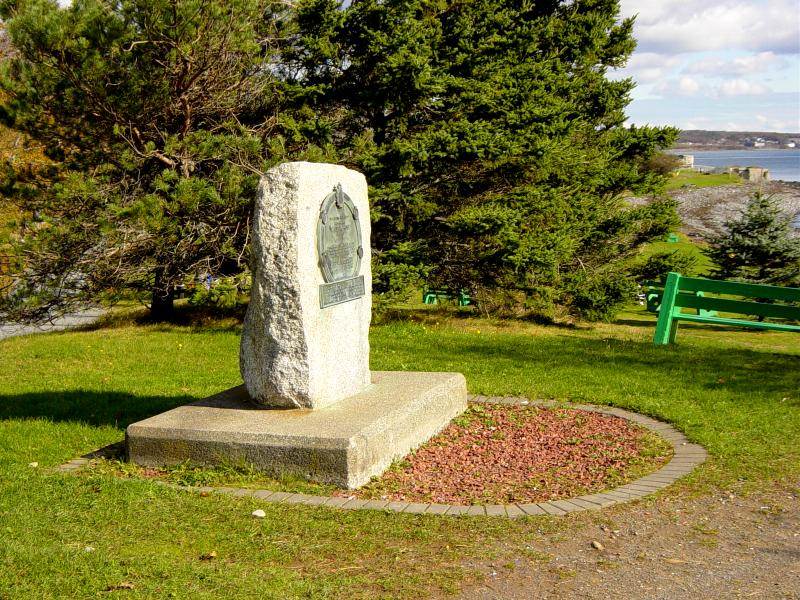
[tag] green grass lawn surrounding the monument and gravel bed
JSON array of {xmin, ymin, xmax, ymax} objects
[{"xmin": 0, "ymin": 309, "xmax": 800, "ymax": 598}]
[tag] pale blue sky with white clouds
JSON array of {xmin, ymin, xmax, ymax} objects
[{"xmin": 612, "ymin": 0, "xmax": 800, "ymax": 132}]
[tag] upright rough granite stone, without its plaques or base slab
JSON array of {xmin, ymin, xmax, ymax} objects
[{"xmin": 240, "ymin": 162, "xmax": 372, "ymax": 408}]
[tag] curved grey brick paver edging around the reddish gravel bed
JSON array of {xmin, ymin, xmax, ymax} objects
[{"xmin": 58, "ymin": 396, "xmax": 708, "ymax": 519}]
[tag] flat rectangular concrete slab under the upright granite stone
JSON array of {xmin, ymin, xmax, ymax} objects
[{"xmin": 125, "ymin": 371, "xmax": 467, "ymax": 489}]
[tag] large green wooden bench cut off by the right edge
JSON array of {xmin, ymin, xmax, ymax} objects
[{"xmin": 653, "ymin": 273, "xmax": 800, "ymax": 346}]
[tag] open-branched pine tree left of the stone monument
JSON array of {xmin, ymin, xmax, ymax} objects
[{"xmin": 0, "ymin": 0, "xmax": 287, "ymax": 320}]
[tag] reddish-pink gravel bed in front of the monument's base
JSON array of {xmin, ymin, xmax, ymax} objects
[{"xmin": 346, "ymin": 404, "xmax": 672, "ymax": 505}]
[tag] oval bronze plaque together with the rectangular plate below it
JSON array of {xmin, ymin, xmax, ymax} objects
[{"xmin": 317, "ymin": 185, "xmax": 364, "ymax": 308}]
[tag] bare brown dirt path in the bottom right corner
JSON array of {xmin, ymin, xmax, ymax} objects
[{"xmin": 462, "ymin": 490, "xmax": 800, "ymax": 600}]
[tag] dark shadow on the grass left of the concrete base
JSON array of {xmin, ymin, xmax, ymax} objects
[{"xmin": 0, "ymin": 390, "xmax": 199, "ymax": 429}]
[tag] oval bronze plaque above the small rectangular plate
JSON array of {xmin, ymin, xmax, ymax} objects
[{"xmin": 317, "ymin": 185, "xmax": 364, "ymax": 283}]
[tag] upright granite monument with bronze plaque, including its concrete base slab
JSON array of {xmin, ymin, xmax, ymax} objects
[{"xmin": 126, "ymin": 162, "xmax": 467, "ymax": 488}]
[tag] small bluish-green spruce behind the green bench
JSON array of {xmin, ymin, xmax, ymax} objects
[{"xmin": 706, "ymin": 193, "xmax": 800, "ymax": 286}]
